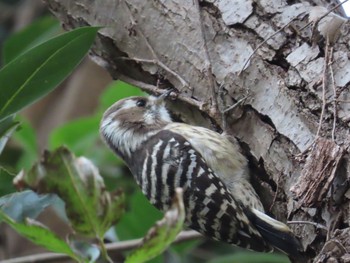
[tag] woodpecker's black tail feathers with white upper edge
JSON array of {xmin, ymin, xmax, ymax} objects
[{"xmin": 247, "ymin": 209, "xmax": 303, "ymax": 256}]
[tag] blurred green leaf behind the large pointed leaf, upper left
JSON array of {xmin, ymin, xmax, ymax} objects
[{"xmin": 3, "ymin": 16, "xmax": 61, "ymax": 64}]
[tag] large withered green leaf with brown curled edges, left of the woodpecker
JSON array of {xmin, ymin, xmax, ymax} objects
[{"xmin": 15, "ymin": 147, "xmax": 124, "ymax": 238}]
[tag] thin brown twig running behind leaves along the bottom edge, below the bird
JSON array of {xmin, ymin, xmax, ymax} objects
[{"xmin": 1, "ymin": 230, "xmax": 203, "ymax": 263}]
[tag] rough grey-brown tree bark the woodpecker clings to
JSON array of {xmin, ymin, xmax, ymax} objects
[{"xmin": 46, "ymin": 0, "xmax": 350, "ymax": 262}]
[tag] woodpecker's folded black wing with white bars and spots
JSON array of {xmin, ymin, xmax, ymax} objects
[{"xmin": 131, "ymin": 130, "xmax": 270, "ymax": 254}]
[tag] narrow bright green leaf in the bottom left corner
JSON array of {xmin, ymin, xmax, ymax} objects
[{"xmin": 0, "ymin": 209, "xmax": 82, "ymax": 262}]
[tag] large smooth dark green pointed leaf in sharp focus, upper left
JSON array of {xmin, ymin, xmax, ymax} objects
[{"xmin": 0, "ymin": 27, "xmax": 99, "ymax": 120}]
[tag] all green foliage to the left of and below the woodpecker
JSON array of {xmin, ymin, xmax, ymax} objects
[{"xmin": 0, "ymin": 15, "xmax": 288, "ymax": 263}]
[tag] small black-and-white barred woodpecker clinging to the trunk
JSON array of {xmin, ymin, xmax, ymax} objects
[{"xmin": 100, "ymin": 93, "xmax": 301, "ymax": 255}]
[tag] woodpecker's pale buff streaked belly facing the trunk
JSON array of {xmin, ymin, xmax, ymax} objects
[{"xmin": 164, "ymin": 123, "xmax": 264, "ymax": 211}]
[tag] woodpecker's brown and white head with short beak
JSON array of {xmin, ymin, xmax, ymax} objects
[{"xmin": 100, "ymin": 92, "xmax": 172, "ymax": 156}]
